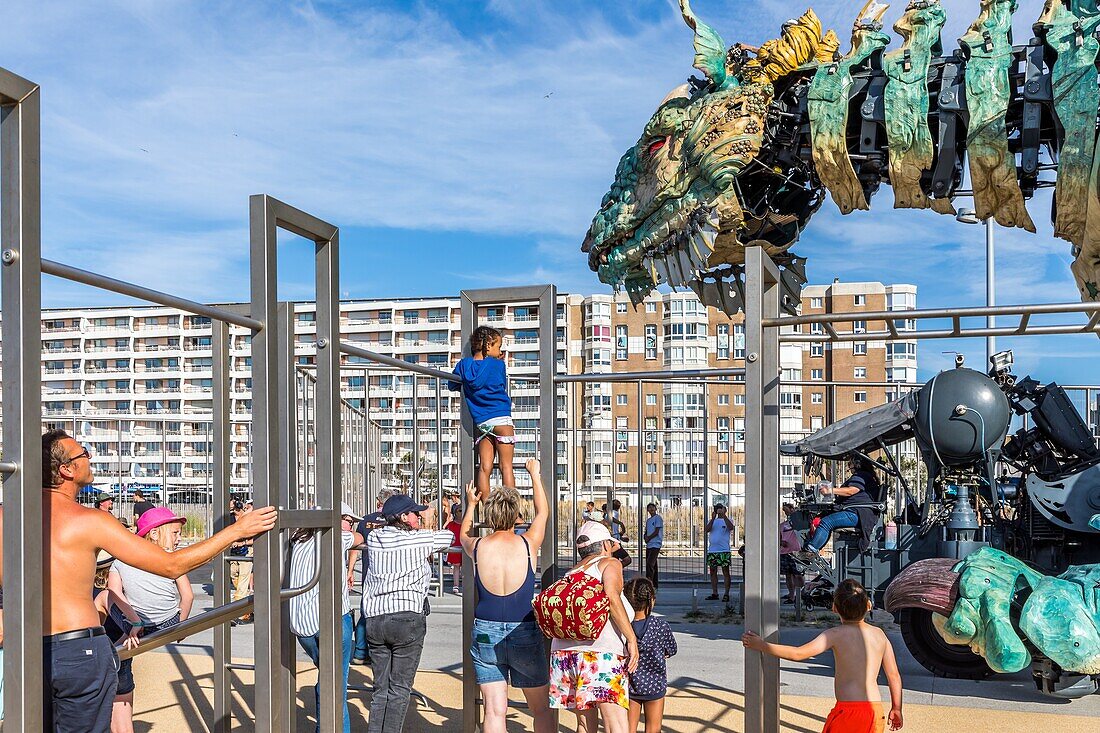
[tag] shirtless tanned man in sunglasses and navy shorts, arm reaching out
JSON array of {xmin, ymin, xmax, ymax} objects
[{"xmin": 0, "ymin": 430, "xmax": 277, "ymax": 733}]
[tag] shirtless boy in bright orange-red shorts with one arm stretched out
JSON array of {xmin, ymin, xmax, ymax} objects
[{"xmin": 741, "ymin": 580, "xmax": 902, "ymax": 733}]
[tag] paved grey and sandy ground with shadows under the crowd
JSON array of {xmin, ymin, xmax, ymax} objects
[{"xmin": 135, "ymin": 572, "xmax": 1100, "ymax": 733}]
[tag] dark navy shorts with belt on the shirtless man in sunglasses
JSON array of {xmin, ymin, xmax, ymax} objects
[{"xmin": 42, "ymin": 635, "xmax": 119, "ymax": 733}]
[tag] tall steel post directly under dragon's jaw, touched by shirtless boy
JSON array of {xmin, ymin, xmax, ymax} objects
[{"xmin": 744, "ymin": 247, "xmax": 780, "ymax": 733}]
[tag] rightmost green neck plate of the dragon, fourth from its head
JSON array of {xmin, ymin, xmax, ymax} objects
[{"xmin": 1037, "ymin": 0, "xmax": 1100, "ymax": 242}]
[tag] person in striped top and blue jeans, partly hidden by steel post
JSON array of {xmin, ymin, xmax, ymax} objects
[{"xmin": 289, "ymin": 503, "xmax": 363, "ymax": 733}]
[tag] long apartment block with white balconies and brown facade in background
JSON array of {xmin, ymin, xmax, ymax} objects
[{"xmin": 8, "ymin": 282, "xmax": 916, "ymax": 502}]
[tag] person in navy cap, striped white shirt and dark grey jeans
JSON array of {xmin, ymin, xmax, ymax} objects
[{"xmin": 363, "ymin": 494, "xmax": 454, "ymax": 733}]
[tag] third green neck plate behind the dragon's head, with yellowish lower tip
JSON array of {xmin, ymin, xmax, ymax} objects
[{"xmin": 959, "ymin": 0, "xmax": 1035, "ymax": 231}]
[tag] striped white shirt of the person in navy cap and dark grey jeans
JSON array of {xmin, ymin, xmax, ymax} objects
[{"xmin": 363, "ymin": 527, "xmax": 454, "ymax": 617}]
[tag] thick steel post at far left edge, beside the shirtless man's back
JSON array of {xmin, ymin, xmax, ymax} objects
[{"xmin": 0, "ymin": 69, "xmax": 44, "ymax": 731}]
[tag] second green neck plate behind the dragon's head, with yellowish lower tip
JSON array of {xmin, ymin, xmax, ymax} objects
[{"xmin": 882, "ymin": 0, "xmax": 954, "ymax": 214}]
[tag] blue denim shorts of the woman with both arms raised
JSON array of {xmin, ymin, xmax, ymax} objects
[{"xmin": 470, "ymin": 619, "xmax": 550, "ymax": 688}]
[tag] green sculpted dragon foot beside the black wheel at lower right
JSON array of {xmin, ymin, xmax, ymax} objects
[{"xmin": 933, "ymin": 547, "xmax": 1100, "ymax": 675}]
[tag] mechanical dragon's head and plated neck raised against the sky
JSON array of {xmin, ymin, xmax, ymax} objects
[{"xmin": 581, "ymin": 0, "xmax": 1100, "ymax": 315}]
